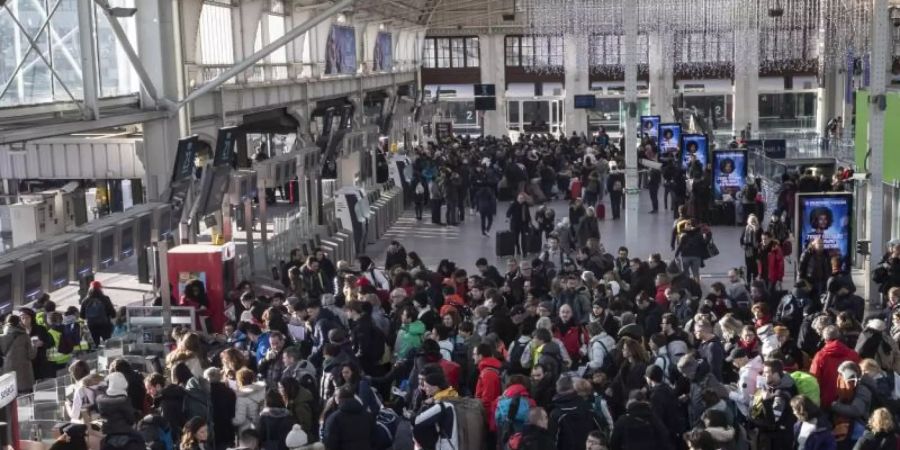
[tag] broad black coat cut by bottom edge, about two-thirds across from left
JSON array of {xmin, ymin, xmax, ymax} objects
[{"xmin": 608, "ymin": 402, "xmax": 672, "ymax": 450}]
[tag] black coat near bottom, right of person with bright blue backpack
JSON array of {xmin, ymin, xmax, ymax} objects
[{"xmin": 548, "ymin": 392, "xmax": 597, "ymax": 450}]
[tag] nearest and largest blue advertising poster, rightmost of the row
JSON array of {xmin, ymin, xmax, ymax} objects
[{"xmin": 795, "ymin": 193, "xmax": 853, "ymax": 270}]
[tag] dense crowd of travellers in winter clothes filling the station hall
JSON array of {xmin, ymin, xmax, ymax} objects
[{"xmin": 10, "ymin": 132, "xmax": 900, "ymax": 450}]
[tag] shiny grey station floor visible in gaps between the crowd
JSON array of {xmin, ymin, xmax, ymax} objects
[{"xmin": 367, "ymin": 192, "xmax": 793, "ymax": 284}]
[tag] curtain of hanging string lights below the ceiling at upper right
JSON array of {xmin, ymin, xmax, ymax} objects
[{"xmin": 519, "ymin": 0, "xmax": 872, "ymax": 76}]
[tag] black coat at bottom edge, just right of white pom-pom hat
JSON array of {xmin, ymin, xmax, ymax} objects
[{"xmin": 322, "ymin": 398, "xmax": 375, "ymax": 450}]
